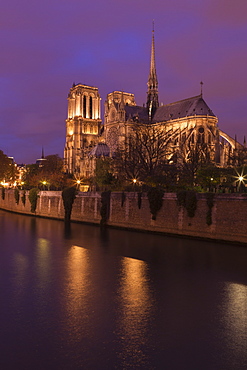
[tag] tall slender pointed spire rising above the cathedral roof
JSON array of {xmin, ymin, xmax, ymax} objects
[{"xmin": 147, "ymin": 21, "xmax": 159, "ymax": 119}]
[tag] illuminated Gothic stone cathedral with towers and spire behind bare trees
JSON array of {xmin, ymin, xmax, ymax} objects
[{"xmin": 64, "ymin": 31, "xmax": 246, "ymax": 178}]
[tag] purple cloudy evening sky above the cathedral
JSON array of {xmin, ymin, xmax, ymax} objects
[{"xmin": 0, "ymin": 0, "xmax": 247, "ymax": 163}]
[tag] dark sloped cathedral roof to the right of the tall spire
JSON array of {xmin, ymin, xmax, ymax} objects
[{"xmin": 153, "ymin": 95, "xmax": 215, "ymax": 122}]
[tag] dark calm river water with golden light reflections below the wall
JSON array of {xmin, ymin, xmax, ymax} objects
[{"xmin": 0, "ymin": 211, "xmax": 247, "ymax": 370}]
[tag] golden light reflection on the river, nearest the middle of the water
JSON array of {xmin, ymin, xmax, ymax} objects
[{"xmin": 116, "ymin": 258, "xmax": 153, "ymax": 368}]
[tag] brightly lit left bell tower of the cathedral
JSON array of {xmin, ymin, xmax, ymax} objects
[{"xmin": 64, "ymin": 84, "xmax": 101, "ymax": 176}]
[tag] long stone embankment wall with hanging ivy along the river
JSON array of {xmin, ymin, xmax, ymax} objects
[{"xmin": 0, "ymin": 190, "xmax": 247, "ymax": 244}]
